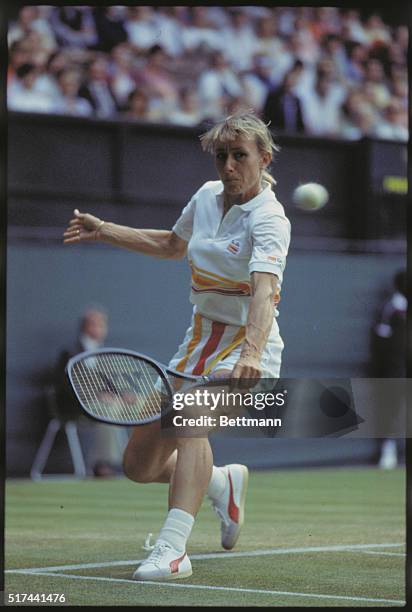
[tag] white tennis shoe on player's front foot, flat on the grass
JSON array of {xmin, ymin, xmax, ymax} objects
[{"xmin": 133, "ymin": 542, "xmax": 192, "ymax": 580}]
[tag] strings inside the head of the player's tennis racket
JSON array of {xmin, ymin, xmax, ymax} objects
[{"xmin": 71, "ymin": 353, "xmax": 169, "ymax": 424}]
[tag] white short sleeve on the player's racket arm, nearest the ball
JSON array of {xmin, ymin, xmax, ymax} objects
[{"xmin": 249, "ymin": 213, "xmax": 290, "ymax": 283}]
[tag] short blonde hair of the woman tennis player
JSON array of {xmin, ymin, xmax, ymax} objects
[{"xmin": 200, "ymin": 111, "xmax": 280, "ymax": 186}]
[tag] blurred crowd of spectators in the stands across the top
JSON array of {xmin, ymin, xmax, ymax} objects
[{"xmin": 7, "ymin": 6, "xmax": 408, "ymax": 141}]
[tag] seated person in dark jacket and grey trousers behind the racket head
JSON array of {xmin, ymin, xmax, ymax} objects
[{"xmin": 54, "ymin": 307, "xmax": 126, "ymax": 476}]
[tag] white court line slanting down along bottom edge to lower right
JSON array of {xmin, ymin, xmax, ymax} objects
[{"xmin": 7, "ymin": 572, "xmax": 405, "ymax": 605}]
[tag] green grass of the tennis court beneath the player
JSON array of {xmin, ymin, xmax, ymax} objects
[{"xmin": 6, "ymin": 469, "xmax": 405, "ymax": 607}]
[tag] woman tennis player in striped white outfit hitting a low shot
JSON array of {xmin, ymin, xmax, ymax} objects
[{"xmin": 64, "ymin": 113, "xmax": 290, "ymax": 580}]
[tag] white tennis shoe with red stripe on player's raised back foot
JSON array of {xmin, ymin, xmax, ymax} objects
[{"xmin": 212, "ymin": 463, "xmax": 249, "ymax": 550}]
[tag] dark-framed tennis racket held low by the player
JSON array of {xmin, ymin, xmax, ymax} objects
[{"xmin": 66, "ymin": 348, "xmax": 213, "ymax": 426}]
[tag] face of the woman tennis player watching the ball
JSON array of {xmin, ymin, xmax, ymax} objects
[{"xmin": 215, "ymin": 136, "xmax": 271, "ymax": 204}]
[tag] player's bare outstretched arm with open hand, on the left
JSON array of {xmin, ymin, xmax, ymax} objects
[{"xmin": 63, "ymin": 210, "xmax": 187, "ymax": 259}]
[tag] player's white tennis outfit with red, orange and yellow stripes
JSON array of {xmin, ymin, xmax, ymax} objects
[{"xmin": 169, "ymin": 181, "xmax": 290, "ymax": 378}]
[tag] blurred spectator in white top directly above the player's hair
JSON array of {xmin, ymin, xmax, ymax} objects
[{"xmin": 198, "ymin": 52, "xmax": 243, "ymax": 119}]
